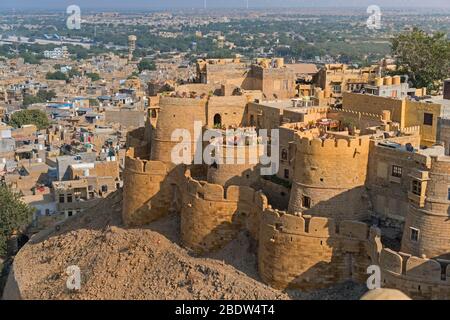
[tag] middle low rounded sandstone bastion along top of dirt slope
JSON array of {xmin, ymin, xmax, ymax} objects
[{"xmin": 181, "ymin": 178, "xmax": 268, "ymax": 253}]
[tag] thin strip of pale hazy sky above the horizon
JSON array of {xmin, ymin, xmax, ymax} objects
[{"xmin": 0, "ymin": 0, "xmax": 450, "ymax": 9}]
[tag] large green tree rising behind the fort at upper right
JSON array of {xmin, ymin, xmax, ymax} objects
[{"xmin": 392, "ymin": 28, "xmax": 450, "ymax": 90}]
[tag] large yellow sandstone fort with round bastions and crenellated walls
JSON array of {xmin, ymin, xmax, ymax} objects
[{"xmin": 123, "ymin": 61, "xmax": 450, "ymax": 299}]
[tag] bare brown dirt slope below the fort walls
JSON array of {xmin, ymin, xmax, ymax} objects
[{"xmin": 4, "ymin": 192, "xmax": 289, "ymax": 299}]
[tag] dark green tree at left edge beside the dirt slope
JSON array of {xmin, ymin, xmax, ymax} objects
[{"xmin": 0, "ymin": 183, "xmax": 34, "ymax": 256}]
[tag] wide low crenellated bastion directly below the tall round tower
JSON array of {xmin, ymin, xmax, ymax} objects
[{"xmin": 258, "ymin": 208, "xmax": 379, "ymax": 290}]
